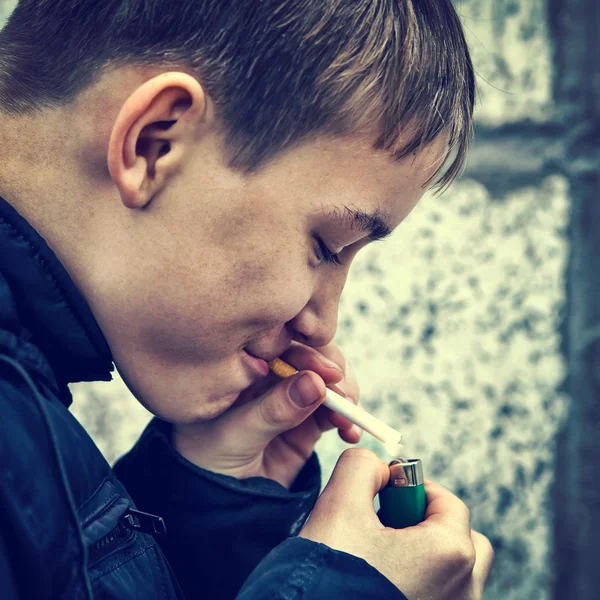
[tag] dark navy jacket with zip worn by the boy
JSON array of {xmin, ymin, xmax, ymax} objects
[{"xmin": 0, "ymin": 198, "xmax": 404, "ymax": 600}]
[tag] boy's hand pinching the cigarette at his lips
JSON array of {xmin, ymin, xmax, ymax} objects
[{"xmin": 174, "ymin": 343, "xmax": 361, "ymax": 488}]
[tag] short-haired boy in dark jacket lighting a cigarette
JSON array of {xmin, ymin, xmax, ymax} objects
[{"xmin": 0, "ymin": 0, "xmax": 492, "ymax": 600}]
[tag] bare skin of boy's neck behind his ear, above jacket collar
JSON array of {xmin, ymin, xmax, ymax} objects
[{"xmin": 0, "ymin": 68, "xmax": 145, "ymax": 255}]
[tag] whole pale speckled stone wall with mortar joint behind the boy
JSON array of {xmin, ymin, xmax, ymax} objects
[{"xmin": 0, "ymin": 0, "xmax": 570, "ymax": 600}]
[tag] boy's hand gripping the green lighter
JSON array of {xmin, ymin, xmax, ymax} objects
[{"xmin": 299, "ymin": 449, "xmax": 494, "ymax": 600}]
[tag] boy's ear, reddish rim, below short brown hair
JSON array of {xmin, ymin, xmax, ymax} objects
[{"xmin": 107, "ymin": 72, "xmax": 207, "ymax": 208}]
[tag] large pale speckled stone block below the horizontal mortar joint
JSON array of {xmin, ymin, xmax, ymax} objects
[{"xmin": 328, "ymin": 174, "xmax": 568, "ymax": 600}]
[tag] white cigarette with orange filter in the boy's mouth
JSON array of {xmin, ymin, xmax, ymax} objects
[{"xmin": 269, "ymin": 358, "xmax": 402, "ymax": 455}]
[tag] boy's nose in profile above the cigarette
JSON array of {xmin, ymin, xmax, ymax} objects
[{"xmin": 288, "ymin": 270, "xmax": 346, "ymax": 348}]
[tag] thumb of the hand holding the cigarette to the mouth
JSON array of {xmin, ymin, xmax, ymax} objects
[{"xmin": 223, "ymin": 371, "xmax": 325, "ymax": 448}]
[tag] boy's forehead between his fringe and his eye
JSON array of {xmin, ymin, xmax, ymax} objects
[{"xmin": 255, "ymin": 137, "xmax": 446, "ymax": 230}]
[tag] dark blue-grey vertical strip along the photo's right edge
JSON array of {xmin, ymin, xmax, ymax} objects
[{"xmin": 549, "ymin": 0, "xmax": 600, "ymax": 600}]
